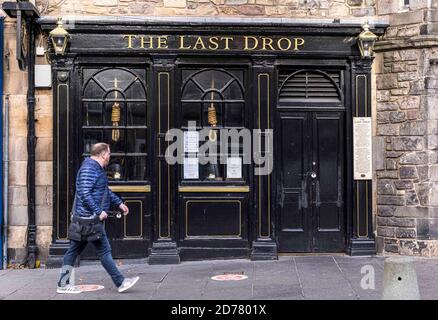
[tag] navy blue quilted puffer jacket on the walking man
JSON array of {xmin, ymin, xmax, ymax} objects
[{"xmin": 73, "ymin": 158, "xmax": 122, "ymax": 217}]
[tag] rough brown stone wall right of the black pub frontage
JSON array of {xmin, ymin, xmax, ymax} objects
[{"xmin": 376, "ymin": 0, "xmax": 438, "ymax": 256}]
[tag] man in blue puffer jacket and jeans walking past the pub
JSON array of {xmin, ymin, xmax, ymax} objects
[{"xmin": 57, "ymin": 143, "xmax": 139, "ymax": 293}]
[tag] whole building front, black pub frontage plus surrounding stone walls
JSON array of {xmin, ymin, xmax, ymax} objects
[{"xmin": 5, "ymin": 0, "xmax": 438, "ymax": 267}]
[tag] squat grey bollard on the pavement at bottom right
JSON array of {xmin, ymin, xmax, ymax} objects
[{"xmin": 382, "ymin": 257, "xmax": 420, "ymax": 300}]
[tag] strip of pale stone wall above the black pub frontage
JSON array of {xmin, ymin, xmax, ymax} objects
[{"xmin": 36, "ymin": 0, "xmax": 376, "ymax": 18}]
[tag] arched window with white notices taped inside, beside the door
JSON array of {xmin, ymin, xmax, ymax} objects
[{"xmin": 181, "ymin": 68, "xmax": 245, "ymax": 182}]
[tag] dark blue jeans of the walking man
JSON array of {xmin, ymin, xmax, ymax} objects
[{"xmin": 58, "ymin": 234, "xmax": 124, "ymax": 287}]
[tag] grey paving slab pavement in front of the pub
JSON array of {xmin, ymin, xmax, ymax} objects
[{"xmin": 0, "ymin": 255, "xmax": 438, "ymax": 300}]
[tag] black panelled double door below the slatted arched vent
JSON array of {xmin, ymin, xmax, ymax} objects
[{"xmin": 274, "ymin": 111, "xmax": 345, "ymax": 252}]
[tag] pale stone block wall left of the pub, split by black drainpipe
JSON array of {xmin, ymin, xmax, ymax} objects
[{"xmin": 4, "ymin": 19, "xmax": 53, "ymax": 263}]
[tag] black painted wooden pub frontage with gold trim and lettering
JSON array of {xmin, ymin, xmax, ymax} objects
[{"xmin": 40, "ymin": 19, "xmax": 384, "ymax": 266}]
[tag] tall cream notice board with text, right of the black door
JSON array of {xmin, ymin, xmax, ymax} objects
[{"xmin": 353, "ymin": 117, "xmax": 373, "ymax": 180}]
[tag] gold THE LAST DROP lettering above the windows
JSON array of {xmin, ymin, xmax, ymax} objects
[{"xmin": 122, "ymin": 34, "xmax": 305, "ymax": 52}]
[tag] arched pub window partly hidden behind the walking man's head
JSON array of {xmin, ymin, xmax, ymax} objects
[{"xmin": 81, "ymin": 68, "xmax": 147, "ymax": 181}]
